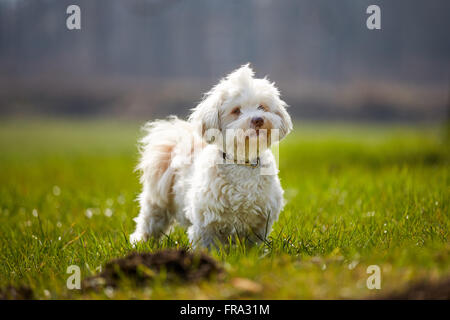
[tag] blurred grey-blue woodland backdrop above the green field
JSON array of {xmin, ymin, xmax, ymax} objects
[{"xmin": 0, "ymin": 0, "xmax": 450, "ymax": 122}]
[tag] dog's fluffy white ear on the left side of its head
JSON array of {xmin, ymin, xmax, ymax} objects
[{"xmin": 189, "ymin": 87, "xmax": 223, "ymax": 135}]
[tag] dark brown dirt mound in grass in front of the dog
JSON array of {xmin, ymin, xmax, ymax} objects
[{"xmin": 83, "ymin": 250, "xmax": 223, "ymax": 290}]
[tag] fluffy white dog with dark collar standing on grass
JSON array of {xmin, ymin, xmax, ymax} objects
[{"xmin": 130, "ymin": 65, "xmax": 292, "ymax": 247}]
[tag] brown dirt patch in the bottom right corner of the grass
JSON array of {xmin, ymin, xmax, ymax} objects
[{"xmin": 376, "ymin": 278, "xmax": 450, "ymax": 300}]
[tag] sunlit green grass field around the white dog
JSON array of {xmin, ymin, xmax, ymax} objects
[{"xmin": 0, "ymin": 120, "xmax": 450, "ymax": 299}]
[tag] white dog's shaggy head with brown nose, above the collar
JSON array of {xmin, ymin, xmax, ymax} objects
[{"xmin": 190, "ymin": 65, "xmax": 292, "ymax": 159}]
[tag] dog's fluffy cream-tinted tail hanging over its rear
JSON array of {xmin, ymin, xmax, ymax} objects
[{"xmin": 136, "ymin": 116, "xmax": 199, "ymax": 207}]
